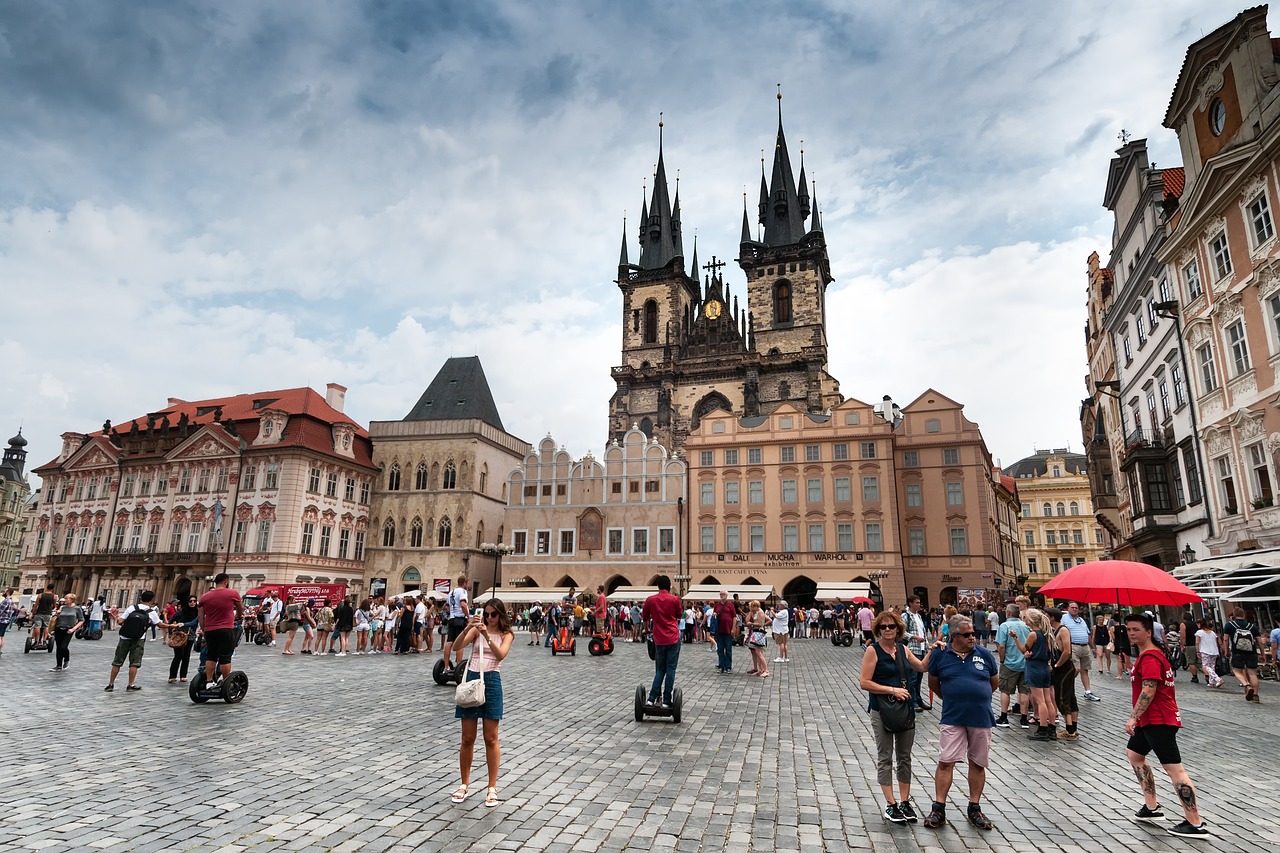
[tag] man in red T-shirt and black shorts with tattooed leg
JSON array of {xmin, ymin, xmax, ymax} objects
[{"xmin": 1124, "ymin": 613, "xmax": 1210, "ymax": 838}]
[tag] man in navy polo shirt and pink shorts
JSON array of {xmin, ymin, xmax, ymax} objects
[{"xmin": 924, "ymin": 616, "xmax": 1000, "ymax": 830}]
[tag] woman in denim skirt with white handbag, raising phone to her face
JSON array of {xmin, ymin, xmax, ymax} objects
[{"xmin": 451, "ymin": 598, "xmax": 516, "ymax": 808}]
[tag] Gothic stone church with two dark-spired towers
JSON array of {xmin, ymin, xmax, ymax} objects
[{"xmin": 608, "ymin": 103, "xmax": 841, "ymax": 448}]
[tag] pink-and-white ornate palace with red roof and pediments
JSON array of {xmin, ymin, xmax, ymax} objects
[{"xmin": 20, "ymin": 384, "xmax": 375, "ymax": 606}]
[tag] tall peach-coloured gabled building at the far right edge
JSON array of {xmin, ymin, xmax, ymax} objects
[{"xmin": 1157, "ymin": 5, "xmax": 1280, "ymax": 557}]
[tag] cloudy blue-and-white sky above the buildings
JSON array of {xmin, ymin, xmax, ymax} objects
[{"xmin": 0, "ymin": 0, "xmax": 1243, "ymax": 479}]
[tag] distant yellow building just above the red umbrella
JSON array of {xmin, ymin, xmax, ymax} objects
[{"xmin": 1007, "ymin": 450, "xmax": 1107, "ymax": 594}]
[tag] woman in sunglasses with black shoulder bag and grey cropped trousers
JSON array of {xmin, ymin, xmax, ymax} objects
[{"xmin": 858, "ymin": 612, "xmax": 933, "ymax": 824}]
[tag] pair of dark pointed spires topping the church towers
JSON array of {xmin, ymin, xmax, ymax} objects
[{"xmin": 618, "ymin": 91, "xmax": 822, "ymax": 268}]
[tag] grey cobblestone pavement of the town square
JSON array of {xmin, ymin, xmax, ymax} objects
[{"xmin": 0, "ymin": 633, "xmax": 1280, "ymax": 853}]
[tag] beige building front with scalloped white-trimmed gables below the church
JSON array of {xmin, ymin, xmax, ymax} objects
[{"xmin": 502, "ymin": 428, "xmax": 687, "ymax": 592}]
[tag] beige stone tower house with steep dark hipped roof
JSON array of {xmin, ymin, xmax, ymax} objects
[{"xmin": 367, "ymin": 356, "xmax": 529, "ymax": 594}]
